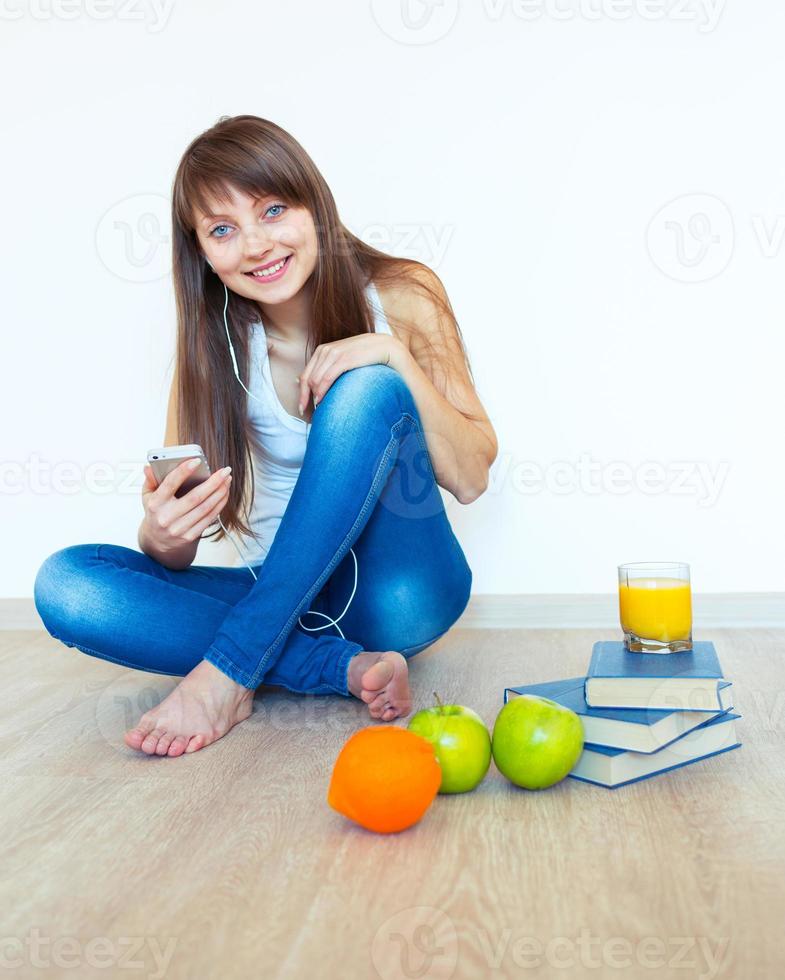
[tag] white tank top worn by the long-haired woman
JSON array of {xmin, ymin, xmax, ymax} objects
[{"xmin": 241, "ymin": 282, "xmax": 392, "ymax": 565}]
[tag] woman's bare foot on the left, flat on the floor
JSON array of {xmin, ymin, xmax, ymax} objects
[{"xmin": 124, "ymin": 660, "xmax": 254, "ymax": 756}]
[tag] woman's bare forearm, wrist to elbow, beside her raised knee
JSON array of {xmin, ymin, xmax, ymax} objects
[{"xmin": 390, "ymin": 344, "xmax": 493, "ymax": 504}]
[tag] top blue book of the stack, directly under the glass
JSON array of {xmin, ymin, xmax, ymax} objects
[{"xmin": 585, "ymin": 640, "xmax": 723, "ymax": 711}]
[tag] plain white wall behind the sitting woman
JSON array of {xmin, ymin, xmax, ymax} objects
[{"xmin": 0, "ymin": 0, "xmax": 785, "ymax": 597}]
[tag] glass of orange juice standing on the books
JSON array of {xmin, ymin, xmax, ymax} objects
[{"xmin": 619, "ymin": 561, "xmax": 692, "ymax": 653}]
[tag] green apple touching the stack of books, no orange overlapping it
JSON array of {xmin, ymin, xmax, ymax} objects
[{"xmin": 492, "ymin": 694, "xmax": 583, "ymax": 789}]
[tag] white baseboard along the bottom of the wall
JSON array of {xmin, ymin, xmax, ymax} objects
[{"xmin": 0, "ymin": 592, "xmax": 785, "ymax": 630}]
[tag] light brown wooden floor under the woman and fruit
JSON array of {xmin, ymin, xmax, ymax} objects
[{"xmin": 0, "ymin": 629, "xmax": 785, "ymax": 980}]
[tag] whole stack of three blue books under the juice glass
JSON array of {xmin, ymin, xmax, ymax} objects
[{"xmin": 504, "ymin": 640, "xmax": 741, "ymax": 788}]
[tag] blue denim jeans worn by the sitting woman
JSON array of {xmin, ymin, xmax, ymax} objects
[{"xmin": 34, "ymin": 364, "xmax": 472, "ymax": 696}]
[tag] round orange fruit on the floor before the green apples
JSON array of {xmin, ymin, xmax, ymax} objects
[{"xmin": 327, "ymin": 725, "xmax": 442, "ymax": 834}]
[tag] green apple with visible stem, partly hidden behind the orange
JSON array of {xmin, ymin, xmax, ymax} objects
[{"xmin": 407, "ymin": 696, "xmax": 491, "ymax": 793}]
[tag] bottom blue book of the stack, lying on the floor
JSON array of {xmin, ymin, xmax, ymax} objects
[{"xmin": 570, "ymin": 712, "xmax": 741, "ymax": 789}]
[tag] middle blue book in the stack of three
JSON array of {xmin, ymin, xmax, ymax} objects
[{"xmin": 504, "ymin": 677, "xmax": 733, "ymax": 752}]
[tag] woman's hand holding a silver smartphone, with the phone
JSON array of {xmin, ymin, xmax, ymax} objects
[{"xmin": 142, "ymin": 446, "xmax": 232, "ymax": 553}]
